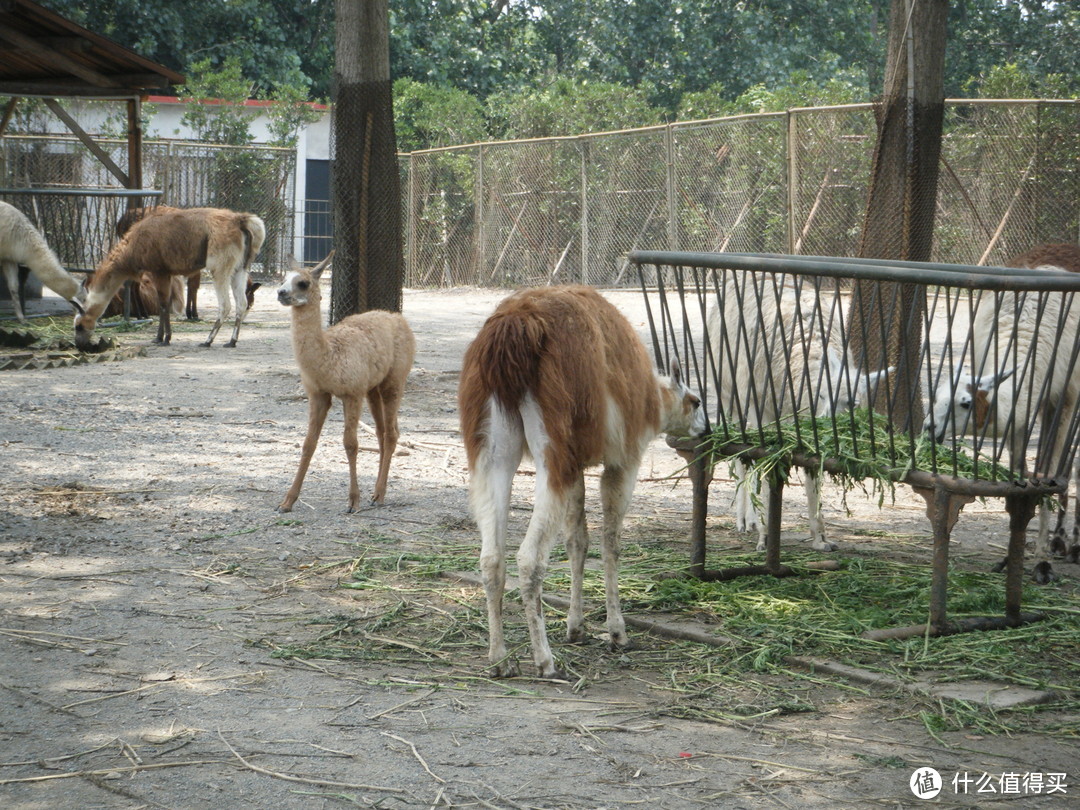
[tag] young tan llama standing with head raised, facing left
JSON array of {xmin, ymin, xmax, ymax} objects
[{"xmin": 278, "ymin": 253, "xmax": 416, "ymax": 512}]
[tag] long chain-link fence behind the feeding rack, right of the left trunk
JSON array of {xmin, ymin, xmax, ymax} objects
[{"xmin": 401, "ymin": 100, "xmax": 1080, "ymax": 287}]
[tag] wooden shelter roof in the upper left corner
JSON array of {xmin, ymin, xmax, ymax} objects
[{"xmin": 0, "ymin": 0, "xmax": 184, "ymax": 98}]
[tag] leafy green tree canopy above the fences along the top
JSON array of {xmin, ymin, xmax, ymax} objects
[{"xmin": 33, "ymin": 0, "xmax": 1080, "ymax": 149}]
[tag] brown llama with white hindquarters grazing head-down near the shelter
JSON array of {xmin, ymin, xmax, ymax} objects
[{"xmin": 75, "ymin": 208, "xmax": 266, "ymax": 350}]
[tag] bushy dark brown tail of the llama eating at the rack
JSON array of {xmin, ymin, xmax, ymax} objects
[{"xmin": 458, "ymin": 312, "xmax": 545, "ymax": 468}]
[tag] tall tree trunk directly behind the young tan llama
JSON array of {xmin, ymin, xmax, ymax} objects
[{"xmin": 329, "ymin": 0, "xmax": 404, "ymax": 323}]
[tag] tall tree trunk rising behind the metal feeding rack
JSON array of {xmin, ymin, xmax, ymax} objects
[{"xmin": 851, "ymin": 0, "xmax": 948, "ymax": 430}]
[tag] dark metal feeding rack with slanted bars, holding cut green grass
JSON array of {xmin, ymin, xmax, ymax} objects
[{"xmin": 630, "ymin": 252, "xmax": 1080, "ymax": 637}]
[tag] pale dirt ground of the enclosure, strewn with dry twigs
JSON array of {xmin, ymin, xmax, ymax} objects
[{"xmin": 0, "ymin": 286, "xmax": 1080, "ymax": 810}]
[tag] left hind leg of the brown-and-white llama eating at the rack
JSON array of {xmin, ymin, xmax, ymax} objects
[{"xmin": 469, "ymin": 402, "xmax": 525, "ymax": 678}]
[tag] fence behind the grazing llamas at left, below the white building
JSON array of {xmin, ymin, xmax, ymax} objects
[{"xmin": 0, "ymin": 135, "xmax": 296, "ymax": 280}]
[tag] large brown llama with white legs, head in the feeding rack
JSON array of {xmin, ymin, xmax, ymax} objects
[{"xmin": 458, "ymin": 286, "xmax": 705, "ymax": 678}]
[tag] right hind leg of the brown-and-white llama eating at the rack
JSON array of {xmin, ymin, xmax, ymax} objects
[{"xmin": 517, "ymin": 394, "xmax": 572, "ymax": 678}]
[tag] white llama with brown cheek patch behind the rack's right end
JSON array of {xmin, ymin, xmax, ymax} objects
[{"xmin": 922, "ymin": 243, "xmax": 1080, "ymax": 584}]
